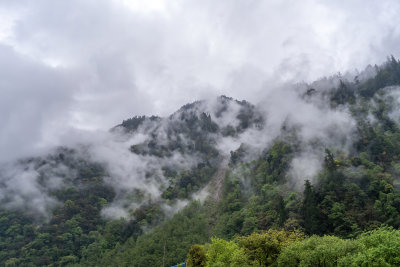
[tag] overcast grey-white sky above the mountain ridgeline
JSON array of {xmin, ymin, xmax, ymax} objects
[{"xmin": 0, "ymin": 0, "xmax": 400, "ymax": 161}]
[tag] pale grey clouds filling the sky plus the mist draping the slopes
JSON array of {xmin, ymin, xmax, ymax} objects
[{"xmin": 0, "ymin": 0, "xmax": 400, "ymax": 220}]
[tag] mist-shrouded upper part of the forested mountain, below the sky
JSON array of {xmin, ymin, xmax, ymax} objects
[{"xmin": 0, "ymin": 58, "xmax": 400, "ymax": 226}]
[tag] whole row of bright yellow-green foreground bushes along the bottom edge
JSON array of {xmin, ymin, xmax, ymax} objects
[{"xmin": 189, "ymin": 227, "xmax": 400, "ymax": 267}]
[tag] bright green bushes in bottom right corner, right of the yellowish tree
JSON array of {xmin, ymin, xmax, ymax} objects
[{"xmin": 278, "ymin": 227, "xmax": 400, "ymax": 266}]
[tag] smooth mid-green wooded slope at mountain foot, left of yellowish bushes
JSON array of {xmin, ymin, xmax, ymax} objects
[{"xmin": 80, "ymin": 202, "xmax": 208, "ymax": 267}]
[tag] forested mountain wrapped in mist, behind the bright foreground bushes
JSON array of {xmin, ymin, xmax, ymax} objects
[{"xmin": 0, "ymin": 57, "xmax": 400, "ymax": 266}]
